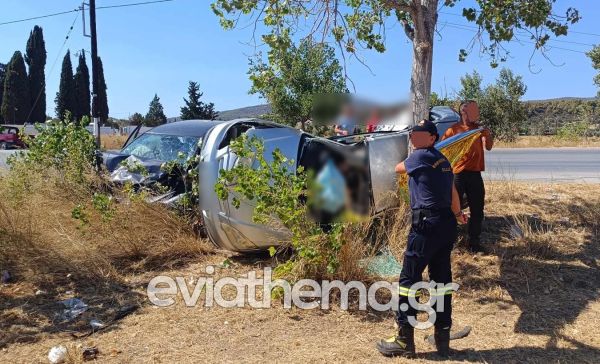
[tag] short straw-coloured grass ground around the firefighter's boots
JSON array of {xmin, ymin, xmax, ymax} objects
[{"xmin": 0, "ymin": 182, "xmax": 600, "ymax": 363}]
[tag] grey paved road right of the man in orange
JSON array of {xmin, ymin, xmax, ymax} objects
[{"xmin": 484, "ymin": 148, "xmax": 600, "ymax": 183}]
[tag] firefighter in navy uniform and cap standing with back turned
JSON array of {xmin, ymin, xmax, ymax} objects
[{"xmin": 377, "ymin": 120, "xmax": 466, "ymax": 357}]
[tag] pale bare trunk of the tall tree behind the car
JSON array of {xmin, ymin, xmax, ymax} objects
[{"xmin": 410, "ymin": 0, "xmax": 438, "ymax": 123}]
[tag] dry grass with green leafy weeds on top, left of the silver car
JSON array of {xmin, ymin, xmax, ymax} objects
[{"xmin": 0, "ymin": 118, "xmax": 211, "ymax": 282}]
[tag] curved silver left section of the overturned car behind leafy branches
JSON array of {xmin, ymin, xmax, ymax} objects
[{"xmin": 199, "ymin": 121, "xmax": 302, "ymax": 251}]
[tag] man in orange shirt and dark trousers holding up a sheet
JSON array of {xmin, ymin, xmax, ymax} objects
[{"xmin": 442, "ymin": 100, "xmax": 494, "ymax": 252}]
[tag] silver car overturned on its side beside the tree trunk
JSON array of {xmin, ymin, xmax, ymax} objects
[{"xmin": 199, "ymin": 119, "xmax": 408, "ymax": 251}]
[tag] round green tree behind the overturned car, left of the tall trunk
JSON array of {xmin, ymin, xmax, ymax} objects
[{"xmin": 248, "ymin": 39, "xmax": 348, "ymax": 126}]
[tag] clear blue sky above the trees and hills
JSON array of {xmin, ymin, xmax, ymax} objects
[{"xmin": 0, "ymin": 0, "xmax": 600, "ymax": 118}]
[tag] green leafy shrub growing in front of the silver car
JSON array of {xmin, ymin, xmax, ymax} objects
[{"xmin": 215, "ymin": 135, "xmax": 344, "ymax": 277}]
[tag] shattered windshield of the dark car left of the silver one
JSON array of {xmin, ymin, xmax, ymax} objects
[{"xmin": 121, "ymin": 133, "xmax": 200, "ymax": 161}]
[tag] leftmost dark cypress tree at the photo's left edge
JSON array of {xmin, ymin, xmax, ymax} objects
[{"xmin": 0, "ymin": 51, "xmax": 31, "ymax": 124}]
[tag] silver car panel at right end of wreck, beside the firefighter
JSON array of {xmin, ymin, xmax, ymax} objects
[{"xmin": 365, "ymin": 132, "xmax": 408, "ymax": 213}]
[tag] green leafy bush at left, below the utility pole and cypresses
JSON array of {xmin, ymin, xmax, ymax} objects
[{"xmin": 10, "ymin": 113, "xmax": 96, "ymax": 182}]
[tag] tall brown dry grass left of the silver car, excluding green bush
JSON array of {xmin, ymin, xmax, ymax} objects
[{"xmin": 0, "ymin": 168, "xmax": 211, "ymax": 348}]
